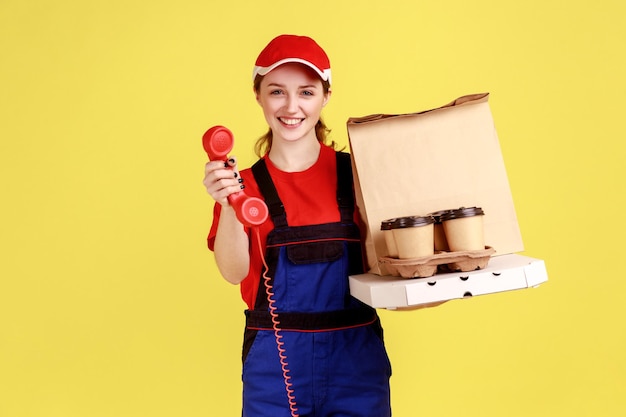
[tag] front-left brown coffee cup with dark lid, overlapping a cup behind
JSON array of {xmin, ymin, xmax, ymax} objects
[{"xmin": 391, "ymin": 216, "xmax": 435, "ymax": 259}]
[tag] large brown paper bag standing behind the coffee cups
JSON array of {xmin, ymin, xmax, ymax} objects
[{"xmin": 347, "ymin": 93, "xmax": 524, "ymax": 275}]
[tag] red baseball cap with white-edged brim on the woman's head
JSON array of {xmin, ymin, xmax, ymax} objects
[{"xmin": 252, "ymin": 35, "xmax": 330, "ymax": 84}]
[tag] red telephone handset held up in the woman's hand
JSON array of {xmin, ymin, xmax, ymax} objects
[{"xmin": 202, "ymin": 126, "xmax": 269, "ymax": 227}]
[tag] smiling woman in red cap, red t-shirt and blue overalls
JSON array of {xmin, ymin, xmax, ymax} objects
[{"xmin": 204, "ymin": 35, "xmax": 391, "ymax": 417}]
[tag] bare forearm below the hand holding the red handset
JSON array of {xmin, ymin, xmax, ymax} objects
[{"xmin": 214, "ymin": 207, "xmax": 250, "ymax": 284}]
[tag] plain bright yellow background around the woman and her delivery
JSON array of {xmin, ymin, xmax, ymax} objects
[{"xmin": 0, "ymin": 0, "xmax": 626, "ymax": 417}]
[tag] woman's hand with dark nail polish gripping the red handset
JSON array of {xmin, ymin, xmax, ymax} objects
[{"xmin": 202, "ymin": 158, "xmax": 243, "ymax": 207}]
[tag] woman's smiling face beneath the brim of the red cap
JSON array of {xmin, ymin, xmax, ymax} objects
[{"xmin": 256, "ymin": 63, "xmax": 330, "ymax": 144}]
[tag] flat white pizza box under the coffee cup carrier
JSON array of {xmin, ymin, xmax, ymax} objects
[{"xmin": 350, "ymin": 254, "xmax": 548, "ymax": 309}]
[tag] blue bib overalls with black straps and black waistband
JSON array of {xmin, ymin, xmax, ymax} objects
[{"xmin": 242, "ymin": 152, "xmax": 391, "ymax": 417}]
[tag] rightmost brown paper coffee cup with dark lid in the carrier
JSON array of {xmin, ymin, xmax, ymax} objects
[{"xmin": 441, "ymin": 207, "xmax": 485, "ymax": 252}]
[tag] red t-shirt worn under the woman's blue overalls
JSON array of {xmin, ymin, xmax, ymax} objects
[{"xmin": 208, "ymin": 145, "xmax": 340, "ymax": 309}]
